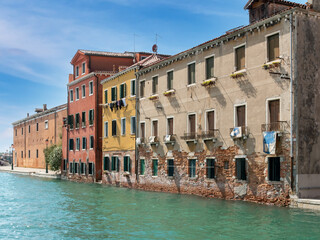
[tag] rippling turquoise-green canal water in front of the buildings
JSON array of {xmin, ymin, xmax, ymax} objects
[{"xmin": 0, "ymin": 172, "xmax": 320, "ymax": 240}]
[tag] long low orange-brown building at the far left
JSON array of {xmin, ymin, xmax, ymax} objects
[{"xmin": 12, "ymin": 104, "xmax": 67, "ymax": 168}]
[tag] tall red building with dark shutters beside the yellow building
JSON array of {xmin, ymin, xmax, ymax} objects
[{"xmin": 61, "ymin": 50, "xmax": 150, "ymax": 182}]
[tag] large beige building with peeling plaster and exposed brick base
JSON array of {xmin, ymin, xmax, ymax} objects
[{"xmin": 136, "ymin": 0, "xmax": 320, "ymax": 205}]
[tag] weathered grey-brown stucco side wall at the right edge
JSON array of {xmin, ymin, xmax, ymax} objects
[{"xmin": 295, "ymin": 14, "xmax": 320, "ymax": 198}]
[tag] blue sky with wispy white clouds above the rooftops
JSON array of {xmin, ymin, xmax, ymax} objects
[{"xmin": 0, "ymin": 0, "xmax": 307, "ymax": 152}]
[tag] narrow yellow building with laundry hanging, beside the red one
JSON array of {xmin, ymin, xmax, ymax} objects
[{"xmin": 101, "ymin": 54, "xmax": 167, "ymax": 186}]
